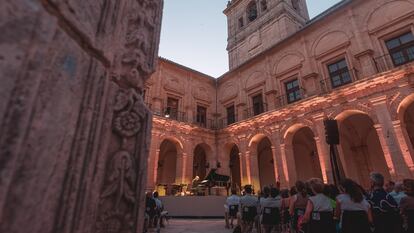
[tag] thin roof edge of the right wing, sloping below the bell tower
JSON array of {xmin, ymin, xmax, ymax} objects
[{"xmin": 217, "ymin": 0, "xmax": 353, "ymax": 80}]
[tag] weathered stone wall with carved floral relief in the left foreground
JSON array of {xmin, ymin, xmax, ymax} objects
[{"xmin": 0, "ymin": 0, "xmax": 162, "ymax": 233}]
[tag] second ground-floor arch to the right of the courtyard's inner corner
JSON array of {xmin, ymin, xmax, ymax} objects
[{"xmin": 247, "ymin": 133, "xmax": 277, "ymax": 189}]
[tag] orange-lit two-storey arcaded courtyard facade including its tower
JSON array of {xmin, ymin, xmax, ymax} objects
[{"xmin": 144, "ymin": 0, "xmax": 414, "ymax": 194}]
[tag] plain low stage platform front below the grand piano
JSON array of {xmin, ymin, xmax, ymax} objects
[{"xmin": 161, "ymin": 196, "xmax": 226, "ymax": 218}]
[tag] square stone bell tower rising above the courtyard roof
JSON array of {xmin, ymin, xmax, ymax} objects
[{"xmin": 224, "ymin": 0, "xmax": 309, "ymax": 70}]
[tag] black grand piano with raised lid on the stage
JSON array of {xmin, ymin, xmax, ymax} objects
[{"xmin": 192, "ymin": 169, "xmax": 231, "ymax": 196}]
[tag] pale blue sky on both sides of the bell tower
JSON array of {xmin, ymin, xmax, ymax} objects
[{"xmin": 159, "ymin": 0, "xmax": 340, "ymax": 77}]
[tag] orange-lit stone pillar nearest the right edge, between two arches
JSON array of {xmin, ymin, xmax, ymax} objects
[{"xmin": 393, "ymin": 120, "xmax": 414, "ymax": 175}]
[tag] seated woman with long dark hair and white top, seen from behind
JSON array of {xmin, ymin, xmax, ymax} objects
[{"xmin": 335, "ymin": 179, "xmax": 373, "ymax": 233}]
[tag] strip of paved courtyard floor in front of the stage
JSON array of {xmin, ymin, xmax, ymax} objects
[{"xmin": 150, "ymin": 219, "xmax": 232, "ymax": 233}]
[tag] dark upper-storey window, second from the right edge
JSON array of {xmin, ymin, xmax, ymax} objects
[{"xmin": 328, "ymin": 59, "xmax": 352, "ymax": 88}]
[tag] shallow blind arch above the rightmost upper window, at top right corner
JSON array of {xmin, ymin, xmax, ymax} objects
[{"xmin": 365, "ymin": 1, "xmax": 414, "ymax": 31}]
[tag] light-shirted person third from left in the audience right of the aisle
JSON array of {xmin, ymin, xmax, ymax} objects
[{"xmin": 260, "ymin": 188, "xmax": 282, "ymax": 233}]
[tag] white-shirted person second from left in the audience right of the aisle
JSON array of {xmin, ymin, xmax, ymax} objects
[{"xmin": 240, "ymin": 185, "xmax": 259, "ymax": 232}]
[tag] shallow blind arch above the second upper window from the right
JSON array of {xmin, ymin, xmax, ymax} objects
[{"xmin": 312, "ymin": 30, "xmax": 349, "ymax": 56}]
